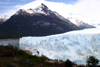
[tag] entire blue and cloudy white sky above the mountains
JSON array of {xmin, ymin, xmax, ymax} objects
[{"xmin": 0, "ymin": 0, "xmax": 100, "ymax": 22}]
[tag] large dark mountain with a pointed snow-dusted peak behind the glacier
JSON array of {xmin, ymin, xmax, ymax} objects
[{"xmin": 0, "ymin": 3, "xmax": 78, "ymax": 38}]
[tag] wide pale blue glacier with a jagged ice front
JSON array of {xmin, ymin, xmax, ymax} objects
[{"xmin": 20, "ymin": 28, "xmax": 100, "ymax": 64}]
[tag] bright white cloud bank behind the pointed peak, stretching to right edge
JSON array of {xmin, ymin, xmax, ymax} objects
[{"xmin": 1, "ymin": 0, "xmax": 100, "ymax": 22}]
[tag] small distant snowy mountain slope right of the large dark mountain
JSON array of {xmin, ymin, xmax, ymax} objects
[{"xmin": 67, "ymin": 17, "xmax": 95, "ymax": 29}]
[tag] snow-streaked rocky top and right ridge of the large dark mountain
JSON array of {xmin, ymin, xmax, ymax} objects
[{"xmin": 15, "ymin": 3, "xmax": 71, "ymax": 24}]
